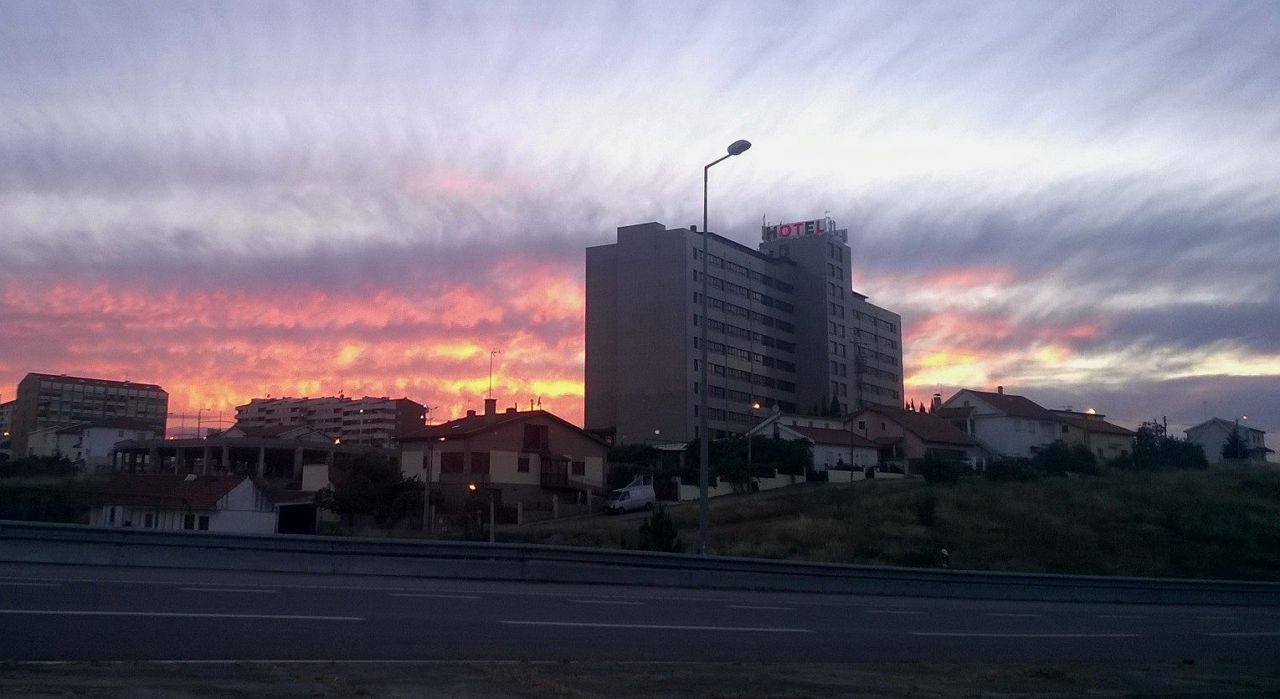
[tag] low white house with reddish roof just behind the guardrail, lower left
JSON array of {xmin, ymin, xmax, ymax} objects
[{"xmin": 90, "ymin": 474, "xmax": 276, "ymax": 534}]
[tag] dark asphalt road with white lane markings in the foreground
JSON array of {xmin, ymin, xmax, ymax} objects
[{"xmin": 0, "ymin": 563, "xmax": 1280, "ymax": 667}]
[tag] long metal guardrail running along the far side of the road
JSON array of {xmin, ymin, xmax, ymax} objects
[{"xmin": 0, "ymin": 521, "xmax": 1280, "ymax": 606}]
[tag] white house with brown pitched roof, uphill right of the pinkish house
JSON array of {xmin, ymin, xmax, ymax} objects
[{"xmin": 934, "ymin": 387, "xmax": 1062, "ymax": 458}]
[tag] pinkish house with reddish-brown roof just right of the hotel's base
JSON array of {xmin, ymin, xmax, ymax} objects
[{"xmin": 849, "ymin": 407, "xmax": 987, "ymax": 472}]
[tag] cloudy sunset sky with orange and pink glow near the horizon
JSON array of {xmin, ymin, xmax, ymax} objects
[{"xmin": 0, "ymin": 0, "xmax": 1280, "ymax": 439}]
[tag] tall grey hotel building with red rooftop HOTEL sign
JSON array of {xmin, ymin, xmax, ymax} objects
[{"xmin": 585, "ymin": 219, "xmax": 902, "ymax": 443}]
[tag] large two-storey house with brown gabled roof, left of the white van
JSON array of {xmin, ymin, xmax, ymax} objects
[{"xmin": 399, "ymin": 398, "xmax": 609, "ymax": 510}]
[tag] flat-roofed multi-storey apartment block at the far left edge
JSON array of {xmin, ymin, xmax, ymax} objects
[{"xmin": 10, "ymin": 374, "xmax": 169, "ymax": 458}]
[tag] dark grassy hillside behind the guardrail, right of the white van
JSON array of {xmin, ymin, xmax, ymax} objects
[{"xmin": 503, "ymin": 471, "xmax": 1280, "ymax": 580}]
